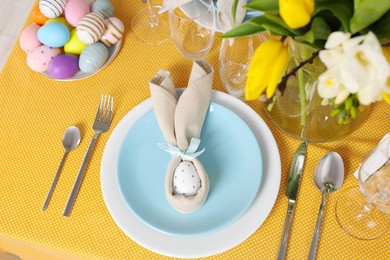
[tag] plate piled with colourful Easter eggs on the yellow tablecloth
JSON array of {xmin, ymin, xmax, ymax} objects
[{"xmin": 19, "ymin": 0, "xmax": 124, "ymax": 80}]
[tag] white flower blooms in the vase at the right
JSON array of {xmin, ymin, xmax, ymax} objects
[{"xmin": 318, "ymin": 32, "xmax": 390, "ymax": 105}]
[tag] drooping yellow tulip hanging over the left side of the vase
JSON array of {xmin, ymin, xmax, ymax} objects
[{"xmin": 245, "ymin": 39, "xmax": 288, "ymax": 100}]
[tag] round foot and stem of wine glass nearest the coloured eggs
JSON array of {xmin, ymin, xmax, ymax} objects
[{"xmin": 131, "ymin": 0, "xmax": 169, "ymax": 44}]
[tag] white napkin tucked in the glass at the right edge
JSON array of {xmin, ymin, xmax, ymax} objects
[{"xmin": 353, "ymin": 133, "xmax": 390, "ymax": 181}]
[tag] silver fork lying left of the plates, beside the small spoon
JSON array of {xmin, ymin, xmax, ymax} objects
[{"xmin": 62, "ymin": 94, "xmax": 114, "ymax": 217}]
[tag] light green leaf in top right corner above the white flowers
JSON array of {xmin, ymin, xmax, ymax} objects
[{"xmin": 350, "ymin": 0, "xmax": 390, "ymax": 34}]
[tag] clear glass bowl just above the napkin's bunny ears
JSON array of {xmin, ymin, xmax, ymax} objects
[{"xmin": 169, "ymin": 0, "xmax": 216, "ymax": 60}]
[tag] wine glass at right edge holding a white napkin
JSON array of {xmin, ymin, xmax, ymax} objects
[{"xmin": 336, "ymin": 136, "xmax": 390, "ymax": 240}]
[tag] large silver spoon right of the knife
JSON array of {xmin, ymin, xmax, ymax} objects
[{"xmin": 308, "ymin": 152, "xmax": 344, "ymax": 260}]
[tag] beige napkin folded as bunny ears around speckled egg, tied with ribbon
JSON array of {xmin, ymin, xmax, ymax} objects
[{"xmin": 149, "ymin": 61, "xmax": 214, "ymax": 213}]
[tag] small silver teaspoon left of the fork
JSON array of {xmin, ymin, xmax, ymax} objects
[{"xmin": 42, "ymin": 126, "xmax": 81, "ymax": 211}]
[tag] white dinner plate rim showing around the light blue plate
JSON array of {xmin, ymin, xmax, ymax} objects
[{"xmin": 101, "ymin": 91, "xmax": 281, "ymax": 258}]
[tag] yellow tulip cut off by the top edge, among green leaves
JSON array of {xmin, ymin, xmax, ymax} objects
[{"xmin": 279, "ymin": 0, "xmax": 315, "ymax": 29}]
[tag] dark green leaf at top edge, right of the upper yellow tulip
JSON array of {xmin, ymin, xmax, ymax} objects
[{"xmin": 313, "ymin": 1, "xmax": 353, "ymax": 32}]
